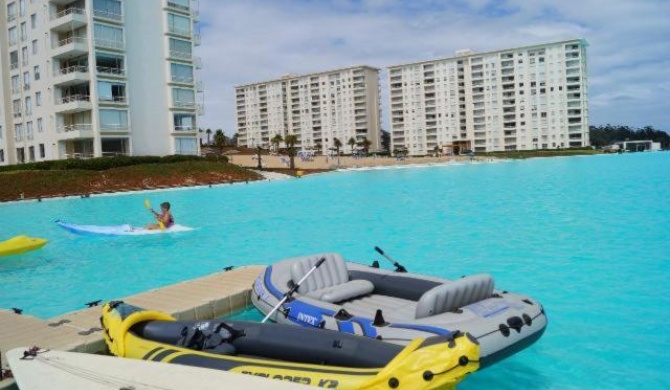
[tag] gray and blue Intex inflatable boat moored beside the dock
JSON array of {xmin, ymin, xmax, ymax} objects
[{"xmin": 251, "ymin": 253, "xmax": 547, "ymax": 367}]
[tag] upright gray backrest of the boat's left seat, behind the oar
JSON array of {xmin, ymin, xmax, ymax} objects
[{"xmin": 291, "ymin": 253, "xmax": 349, "ymax": 294}]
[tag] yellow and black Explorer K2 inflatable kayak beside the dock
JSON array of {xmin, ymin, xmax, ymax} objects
[{"xmin": 101, "ymin": 301, "xmax": 479, "ymax": 389}]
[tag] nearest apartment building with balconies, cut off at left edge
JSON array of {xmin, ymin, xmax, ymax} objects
[{"xmin": 0, "ymin": 0, "xmax": 202, "ymax": 164}]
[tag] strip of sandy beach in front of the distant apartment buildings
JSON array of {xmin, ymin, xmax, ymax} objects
[{"xmin": 228, "ymin": 154, "xmax": 491, "ymax": 169}]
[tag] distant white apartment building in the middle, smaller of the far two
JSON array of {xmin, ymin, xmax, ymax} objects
[{"xmin": 235, "ymin": 66, "xmax": 381, "ymax": 154}]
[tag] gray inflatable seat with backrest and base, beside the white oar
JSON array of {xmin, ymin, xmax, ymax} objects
[{"xmin": 291, "ymin": 253, "xmax": 375, "ymax": 303}]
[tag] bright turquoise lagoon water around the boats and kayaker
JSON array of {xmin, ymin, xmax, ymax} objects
[{"xmin": 0, "ymin": 153, "xmax": 670, "ymax": 390}]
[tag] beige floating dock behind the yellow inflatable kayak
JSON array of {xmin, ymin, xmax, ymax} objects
[{"xmin": 0, "ymin": 266, "xmax": 264, "ymax": 389}]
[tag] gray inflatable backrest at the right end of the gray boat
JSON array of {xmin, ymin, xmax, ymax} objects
[{"xmin": 415, "ymin": 274, "xmax": 493, "ymax": 319}]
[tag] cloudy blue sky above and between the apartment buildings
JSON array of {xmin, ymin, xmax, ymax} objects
[{"xmin": 196, "ymin": 0, "xmax": 670, "ymax": 135}]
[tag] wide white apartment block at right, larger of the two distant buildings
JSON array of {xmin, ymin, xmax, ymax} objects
[{"xmin": 388, "ymin": 39, "xmax": 589, "ymax": 155}]
